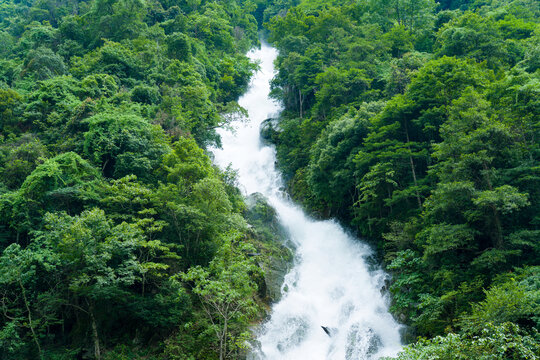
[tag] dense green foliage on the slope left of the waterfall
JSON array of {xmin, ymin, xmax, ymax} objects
[{"xmin": 0, "ymin": 0, "xmax": 261, "ymax": 360}]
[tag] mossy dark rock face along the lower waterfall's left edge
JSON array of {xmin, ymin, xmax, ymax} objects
[{"xmin": 244, "ymin": 193, "xmax": 293, "ymax": 303}]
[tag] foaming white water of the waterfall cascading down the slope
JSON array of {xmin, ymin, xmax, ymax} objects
[{"xmin": 213, "ymin": 44, "xmax": 401, "ymax": 360}]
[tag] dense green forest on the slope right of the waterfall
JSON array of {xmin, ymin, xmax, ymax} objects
[{"xmin": 266, "ymin": 0, "xmax": 540, "ymax": 359}]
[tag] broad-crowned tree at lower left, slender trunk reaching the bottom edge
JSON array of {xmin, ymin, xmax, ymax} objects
[{"xmin": 35, "ymin": 209, "xmax": 143, "ymax": 360}]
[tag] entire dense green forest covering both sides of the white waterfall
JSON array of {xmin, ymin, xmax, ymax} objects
[{"xmin": 0, "ymin": 0, "xmax": 540, "ymax": 360}]
